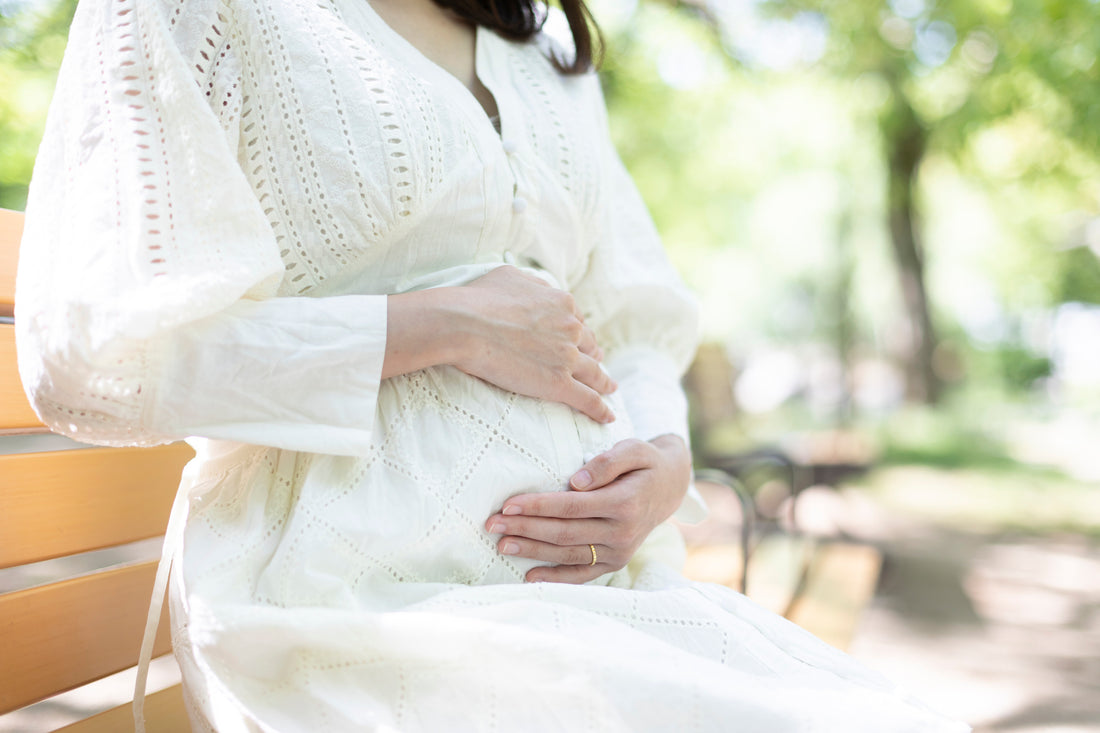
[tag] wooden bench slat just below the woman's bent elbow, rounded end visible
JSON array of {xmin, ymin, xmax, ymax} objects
[{"xmin": 0, "ymin": 442, "xmax": 194, "ymax": 568}]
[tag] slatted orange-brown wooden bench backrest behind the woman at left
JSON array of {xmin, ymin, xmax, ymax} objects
[{"xmin": 0, "ymin": 210, "xmax": 193, "ymax": 731}]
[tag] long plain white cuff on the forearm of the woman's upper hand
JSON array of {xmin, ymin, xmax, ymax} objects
[{"xmin": 146, "ymin": 295, "xmax": 386, "ymax": 456}]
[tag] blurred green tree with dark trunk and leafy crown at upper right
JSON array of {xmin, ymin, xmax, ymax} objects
[{"xmin": 651, "ymin": 0, "xmax": 1100, "ymax": 402}]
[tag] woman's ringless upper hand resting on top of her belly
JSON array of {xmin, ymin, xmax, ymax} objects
[{"xmin": 452, "ymin": 265, "xmax": 616, "ymax": 423}]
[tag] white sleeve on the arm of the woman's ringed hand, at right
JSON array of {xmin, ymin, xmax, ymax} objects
[{"xmin": 573, "ymin": 75, "xmax": 705, "ymax": 522}]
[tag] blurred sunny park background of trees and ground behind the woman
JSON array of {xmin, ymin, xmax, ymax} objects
[{"xmin": 0, "ymin": 0, "xmax": 1100, "ymax": 733}]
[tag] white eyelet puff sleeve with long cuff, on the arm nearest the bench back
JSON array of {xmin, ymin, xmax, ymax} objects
[{"xmin": 15, "ymin": 0, "xmax": 386, "ymax": 455}]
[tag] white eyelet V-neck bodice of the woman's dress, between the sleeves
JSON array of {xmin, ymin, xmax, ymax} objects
[{"xmin": 245, "ymin": 0, "xmax": 620, "ymax": 295}]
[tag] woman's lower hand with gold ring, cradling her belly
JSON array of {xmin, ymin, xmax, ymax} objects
[{"xmin": 485, "ymin": 435, "xmax": 691, "ymax": 583}]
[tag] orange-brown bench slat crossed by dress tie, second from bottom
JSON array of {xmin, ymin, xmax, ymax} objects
[{"xmin": 0, "ymin": 561, "xmax": 172, "ymax": 714}]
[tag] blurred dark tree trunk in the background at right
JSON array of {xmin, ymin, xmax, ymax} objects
[{"xmin": 881, "ymin": 87, "xmax": 942, "ymax": 404}]
